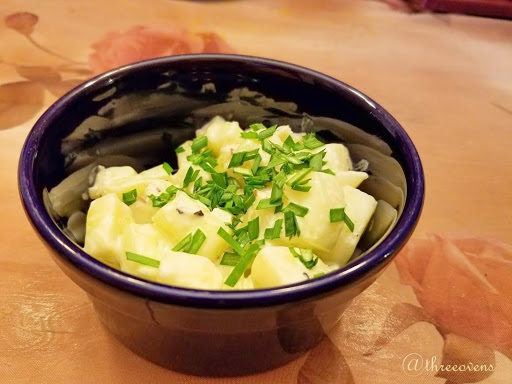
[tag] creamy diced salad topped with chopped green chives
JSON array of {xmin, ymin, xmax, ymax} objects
[{"xmin": 84, "ymin": 117, "xmax": 377, "ymax": 290}]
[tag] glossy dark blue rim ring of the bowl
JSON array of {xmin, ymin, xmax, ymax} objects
[{"xmin": 18, "ymin": 54, "xmax": 425, "ymax": 309}]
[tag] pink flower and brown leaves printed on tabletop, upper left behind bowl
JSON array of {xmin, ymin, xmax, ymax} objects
[{"xmin": 0, "ymin": 12, "xmax": 234, "ymax": 130}]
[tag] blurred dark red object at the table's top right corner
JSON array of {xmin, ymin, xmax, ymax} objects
[{"xmin": 407, "ymin": 0, "xmax": 512, "ymax": 19}]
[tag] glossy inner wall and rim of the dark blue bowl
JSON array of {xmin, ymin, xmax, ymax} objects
[{"xmin": 20, "ymin": 55, "xmax": 424, "ymax": 308}]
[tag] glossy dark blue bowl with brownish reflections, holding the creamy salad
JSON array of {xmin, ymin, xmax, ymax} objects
[{"xmin": 19, "ymin": 55, "xmax": 424, "ymax": 375}]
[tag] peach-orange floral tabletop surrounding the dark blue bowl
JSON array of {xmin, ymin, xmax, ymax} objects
[{"xmin": 0, "ymin": 0, "xmax": 512, "ymax": 384}]
